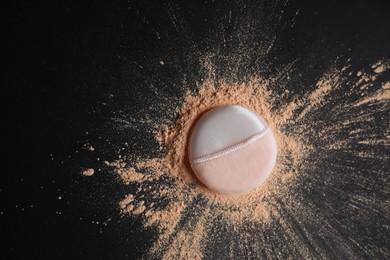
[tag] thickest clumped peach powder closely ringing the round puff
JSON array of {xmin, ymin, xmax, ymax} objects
[{"xmin": 104, "ymin": 75, "xmax": 310, "ymax": 259}]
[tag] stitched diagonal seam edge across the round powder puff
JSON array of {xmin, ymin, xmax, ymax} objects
[{"xmin": 191, "ymin": 126, "xmax": 270, "ymax": 164}]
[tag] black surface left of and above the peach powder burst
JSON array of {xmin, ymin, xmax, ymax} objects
[{"xmin": 0, "ymin": 1, "xmax": 390, "ymax": 259}]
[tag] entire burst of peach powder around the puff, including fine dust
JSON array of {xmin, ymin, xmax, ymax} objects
[{"xmin": 77, "ymin": 1, "xmax": 390, "ymax": 259}]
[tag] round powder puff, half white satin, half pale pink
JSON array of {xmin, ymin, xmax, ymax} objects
[{"xmin": 189, "ymin": 106, "xmax": 277, "ymax": 194}]
